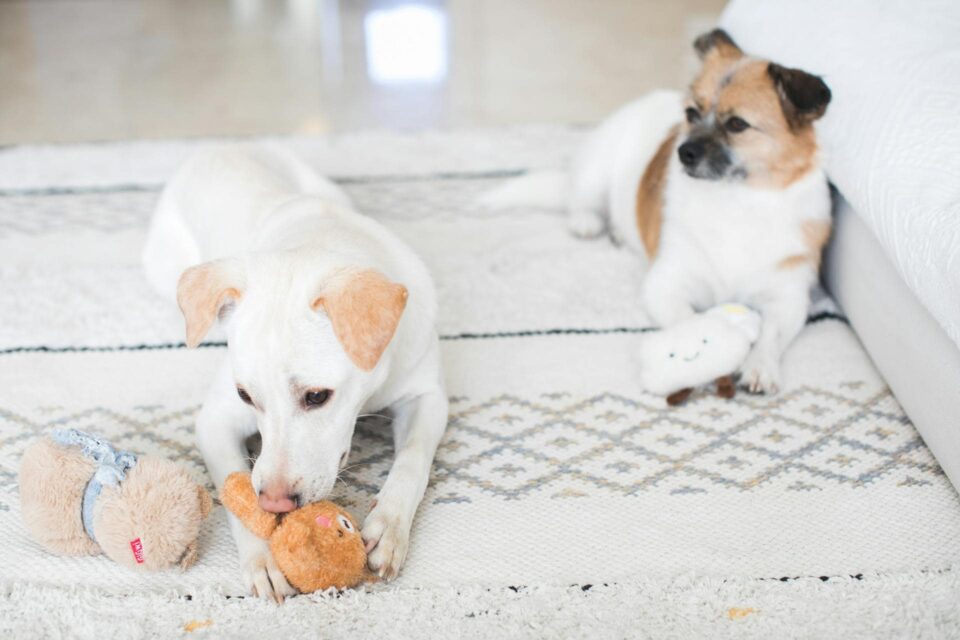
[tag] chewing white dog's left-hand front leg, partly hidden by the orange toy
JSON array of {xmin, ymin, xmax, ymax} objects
[{"xmin": 197, "ymin": 361, "xmax": 296, "ymax": 602}]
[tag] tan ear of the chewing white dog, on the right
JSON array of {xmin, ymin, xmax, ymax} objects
[{"xmin": 311, "ymin": 269, "xmax": 407, "ymax": 371}]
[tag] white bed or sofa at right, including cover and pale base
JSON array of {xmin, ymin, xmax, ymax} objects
[{"xmin": 721, "ymin": 0, "xmax": 960, "ymax": 487}]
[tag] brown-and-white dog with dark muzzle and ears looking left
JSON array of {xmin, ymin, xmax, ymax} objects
[{"xmin": 484, "ymin": 29, "xmax": 830, "ymax": 393}]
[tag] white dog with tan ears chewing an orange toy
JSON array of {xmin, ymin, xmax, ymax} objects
[{"xmin": 144, "ymin": 148, "xmax": 447, "ymax": 600}]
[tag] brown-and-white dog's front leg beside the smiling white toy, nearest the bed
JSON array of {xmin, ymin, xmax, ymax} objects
[{"xmin": 740, "ymin": 279, "xmax": 810, "ymax": 394}]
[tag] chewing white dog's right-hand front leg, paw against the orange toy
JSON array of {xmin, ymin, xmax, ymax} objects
[{"xmin": 362, "ymin": 388, "xmax": 447, "ymax": 580}]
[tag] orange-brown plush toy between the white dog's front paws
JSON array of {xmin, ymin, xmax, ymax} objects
[{"xmin": 220, "ymin": 473, "xmax": 375, "ymax": 593}]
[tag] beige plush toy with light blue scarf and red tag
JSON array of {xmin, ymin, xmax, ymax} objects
[{"xmin": 19, "ymin": 429, "xmax": 213, "ymax": 569}]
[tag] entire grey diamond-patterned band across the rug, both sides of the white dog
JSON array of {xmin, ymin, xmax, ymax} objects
[{"xmin": 0, "ymin": 387, "xmax": 945, "ymax": 508}]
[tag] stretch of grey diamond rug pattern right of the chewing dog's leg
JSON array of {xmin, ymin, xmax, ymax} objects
[{"xmin": 434, "ymin": 387, "xmax": 943, "ymax": 500}]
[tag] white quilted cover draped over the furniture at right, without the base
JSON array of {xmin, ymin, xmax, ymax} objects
[{"xmin": 721, "ymin": 0, "xmax": 960, "ymax": 345}]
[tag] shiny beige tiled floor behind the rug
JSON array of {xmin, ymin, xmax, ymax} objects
[{"xmin": 0, "ymin": 0, "xmax": 724, "ymax": 144}]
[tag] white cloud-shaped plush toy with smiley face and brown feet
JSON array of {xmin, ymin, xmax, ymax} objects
[{"xmin": 640, "ymin": 304, "xmax": 761, "ymax": 405}]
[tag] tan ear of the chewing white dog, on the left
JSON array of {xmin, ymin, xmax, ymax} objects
[{"xmin": 177, "ymin": 258, "xmax": 245, "ymax": 347}]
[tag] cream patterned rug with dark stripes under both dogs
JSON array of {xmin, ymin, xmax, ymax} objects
[{"xmin": 0, "ymin": 128, "xmax": 960, "ymax": 637}]
